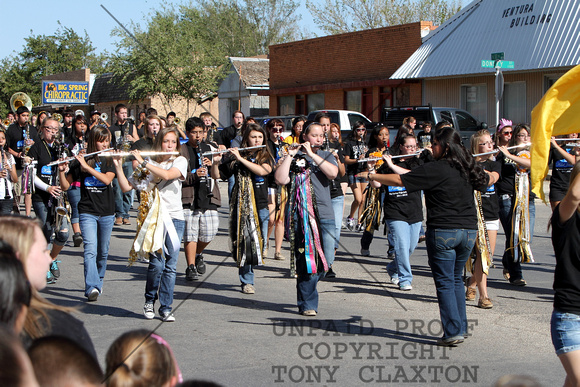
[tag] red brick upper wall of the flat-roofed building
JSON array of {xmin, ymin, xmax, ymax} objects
[{"xmin": 270, "ymin": 22, "xmax": 430, "ymax": 90}]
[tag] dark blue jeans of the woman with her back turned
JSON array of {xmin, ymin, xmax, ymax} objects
[{"xmin": 425, "ymin": 228, "xmax": 477, "ymax": 339}]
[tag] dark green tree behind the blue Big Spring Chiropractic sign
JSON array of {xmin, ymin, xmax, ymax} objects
[{"xmin": 0, "ymin": 23, "xmax": 107, "ymax": 117}]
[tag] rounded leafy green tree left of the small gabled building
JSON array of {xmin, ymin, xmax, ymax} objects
[{"xmin": 111, "ymin": 6, "xmax": 226, "ymax": 115}]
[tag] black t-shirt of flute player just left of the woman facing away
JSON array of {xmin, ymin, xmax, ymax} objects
[{"xmin": 379, "ymin": 157, "xmax": 423, "ymax": 224}]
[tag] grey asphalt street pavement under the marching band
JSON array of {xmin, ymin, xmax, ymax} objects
[{"xmin": 43, "ymin": 183, "xmax": 565, "ymax": 386}]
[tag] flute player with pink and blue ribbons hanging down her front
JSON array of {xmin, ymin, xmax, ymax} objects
[{"xmin": 275, "ymin": 123, "xmax": 338, "ymax": 316}]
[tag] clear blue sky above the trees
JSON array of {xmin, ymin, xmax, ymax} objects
[{"xmin": 0, "ymin": 0, "xmax": 322, "ymax": 59}]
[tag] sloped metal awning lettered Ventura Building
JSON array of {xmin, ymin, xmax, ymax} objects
[{"xmin": 391, "ymin": 0, "xmax": 580, "ymax": 79}]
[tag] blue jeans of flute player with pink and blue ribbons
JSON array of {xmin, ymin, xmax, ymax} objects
[{"xmin": 294, "ymin": 219, "xmax": 342, "ymax": 313}]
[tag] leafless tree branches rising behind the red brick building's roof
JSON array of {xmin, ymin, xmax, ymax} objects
[{"xmin": 306, "ymin": 0, "xmax": 461, "ymax": 34}]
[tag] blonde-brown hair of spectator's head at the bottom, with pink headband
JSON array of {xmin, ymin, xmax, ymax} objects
[{"xmin": 105, "ymin": 329, "xmax": 180, "ymax": 387}]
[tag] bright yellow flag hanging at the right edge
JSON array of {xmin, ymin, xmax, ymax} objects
[{"xmin": 531, "ymin": 65, "xmax": 580, "ymax": 201}]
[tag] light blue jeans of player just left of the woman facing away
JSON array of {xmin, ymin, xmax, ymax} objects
[{"xmin": 386, "ymin": 219, "xmax": 421, "ymax": 286}]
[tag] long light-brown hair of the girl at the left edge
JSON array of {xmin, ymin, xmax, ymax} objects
[{"xmin": 0, "ymin": 215, "xmax": 76, "ymax": 339}]
